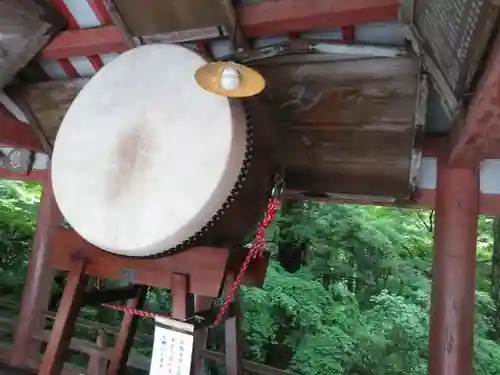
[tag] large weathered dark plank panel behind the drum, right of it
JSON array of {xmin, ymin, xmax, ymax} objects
[{"xmin": 256, "ymin": 55, "xmax": 420, "ymax": 198}]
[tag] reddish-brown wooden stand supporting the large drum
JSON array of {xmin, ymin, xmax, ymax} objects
[{"xmin": 39, "ymin": 228, "xmax": 268, "ymax": 375}]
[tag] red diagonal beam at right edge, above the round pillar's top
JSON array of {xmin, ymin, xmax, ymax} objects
[{"xmin": 450, "ymin": 37, "xmax": 500, "ymax": 167}]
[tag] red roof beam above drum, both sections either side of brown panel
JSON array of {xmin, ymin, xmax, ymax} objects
[{"xmin": 40, "ymin": 0, "xmax": 399, "ymax": 59}]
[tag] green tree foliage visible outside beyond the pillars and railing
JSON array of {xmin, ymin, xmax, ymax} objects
[{"xmin": 0, "ymin": 185, "xmax": 500, "ymax": 375}]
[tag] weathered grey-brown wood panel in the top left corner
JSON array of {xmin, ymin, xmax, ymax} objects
[{"xmin": 0, "ymin": 0, "xmax": 63, "ymax": 90}]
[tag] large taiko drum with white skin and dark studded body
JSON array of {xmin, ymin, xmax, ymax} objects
[{"xmin": 52, "ymin": 45, "xmax": 276, "ymax": 257}]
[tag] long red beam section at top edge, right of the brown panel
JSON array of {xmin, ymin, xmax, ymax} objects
[{"xmin": 237, "ymin": 0, "xmax": 399, "ymax": 37}]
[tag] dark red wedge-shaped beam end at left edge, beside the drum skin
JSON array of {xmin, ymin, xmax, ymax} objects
[{"xmin": 0, "ymin": 104, "xmax": 43, "ymax": 152}]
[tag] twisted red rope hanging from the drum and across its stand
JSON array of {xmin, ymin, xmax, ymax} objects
[{"xmin": 103, "ymin": 198, "xmax": 280, "ymax": 327}]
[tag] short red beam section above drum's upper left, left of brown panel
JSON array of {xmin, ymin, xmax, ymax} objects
[{"xmin": 40, "ymin": 26, "xmax": 129, "ymax": 59}]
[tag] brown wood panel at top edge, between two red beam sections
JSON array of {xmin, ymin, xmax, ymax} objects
[{"xmin": 114, "ymin": 0, "xmax": 231, "ymax": 36}]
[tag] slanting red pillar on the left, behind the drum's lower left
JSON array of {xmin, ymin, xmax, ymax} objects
[{"xmin": 10, "ymin": 171, "xmax": 62, "ymax": 366}]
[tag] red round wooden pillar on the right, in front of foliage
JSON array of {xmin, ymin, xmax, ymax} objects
[{"xmin": 429, "ymin": 163, "xmax": 479, "ymax": 375}]
